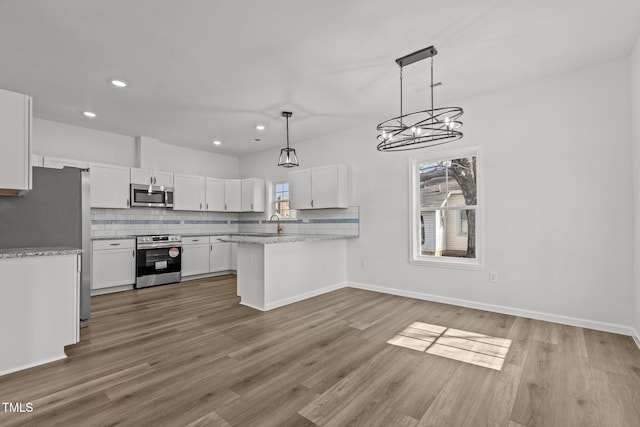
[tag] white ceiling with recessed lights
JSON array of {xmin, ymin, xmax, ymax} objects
[{"xmin": 0, "ymin": 0, "xmax": 640, "ymax": 156}]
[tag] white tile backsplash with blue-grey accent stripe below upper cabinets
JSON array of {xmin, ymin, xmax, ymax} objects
[{"xmin": 91, "ymin": 206, "xmax": 360, "ymax": 237}]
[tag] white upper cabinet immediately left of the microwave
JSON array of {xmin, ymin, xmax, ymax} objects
[{"xmin": 89, "ymin": 163, "xmax": 131, "ymax": 208}]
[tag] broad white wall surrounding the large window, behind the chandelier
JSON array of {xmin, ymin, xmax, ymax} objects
[{"xmin": 240, "ymin": 59, "xmax": 634, "ymax": 329}]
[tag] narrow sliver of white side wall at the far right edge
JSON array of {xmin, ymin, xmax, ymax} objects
[{"xmin": 630, "ymin": 37, "xmax": 640, "ymax": 345}]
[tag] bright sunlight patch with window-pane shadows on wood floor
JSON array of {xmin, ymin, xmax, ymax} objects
[{"xmin": 387, "ymin": 322, "xmax": 511, "ymax": 371}]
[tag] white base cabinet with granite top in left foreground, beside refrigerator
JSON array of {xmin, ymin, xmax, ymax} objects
[{"xmin": 0, "ymin": 247, "xmax": 82, "ymax": 375}]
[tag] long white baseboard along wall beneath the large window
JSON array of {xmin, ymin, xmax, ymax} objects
[{"xmin": 347, "ymin": 282, "xmax": 640, "ymax": 342}]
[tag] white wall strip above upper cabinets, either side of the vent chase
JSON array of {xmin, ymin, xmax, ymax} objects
[{"xmin": 32, "ymin": 118, "xmax": 239, "ymax": 178}]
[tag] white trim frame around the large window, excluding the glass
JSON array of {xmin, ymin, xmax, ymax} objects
[{"xmin": 408, "ymin": 146, "xmax": 484, "ymax": 270}]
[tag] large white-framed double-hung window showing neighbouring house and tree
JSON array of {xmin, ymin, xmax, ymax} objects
[{"xmin": 410, "ymin": 149, "xmax": 481, "ymax": 267}]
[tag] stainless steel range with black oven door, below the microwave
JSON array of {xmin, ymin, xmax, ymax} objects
[{"xmin": 135, "ymin": 236, "xmax": 182, "ymax": 289}]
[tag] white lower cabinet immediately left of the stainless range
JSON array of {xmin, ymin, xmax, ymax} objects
[{"xmin": 91, "ymin": 239, "xmax": 136, "ymax": 290}]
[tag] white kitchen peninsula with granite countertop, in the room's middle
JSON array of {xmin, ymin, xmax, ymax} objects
[{"xmin": 225, "ymin": 234, "xmax": 355, "ymax": 311}]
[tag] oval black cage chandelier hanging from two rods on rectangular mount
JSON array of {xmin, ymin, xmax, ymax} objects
[{"xmin": 377, "ymin": 46, "xmax": 462, "ymax": 151}]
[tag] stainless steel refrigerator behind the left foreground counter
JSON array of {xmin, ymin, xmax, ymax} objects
[{"xmin": 0, "ymin": 167, "xmax": 91, "ymax": 323}]
